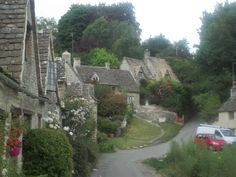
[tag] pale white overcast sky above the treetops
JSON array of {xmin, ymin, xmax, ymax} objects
[{"xmin": 35, "ymin": 0, "xmax": 236, "ymax": 51}]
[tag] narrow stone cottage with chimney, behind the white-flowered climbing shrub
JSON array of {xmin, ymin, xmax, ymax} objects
[{"xmin": 55, "ymin": 51, "xmax": 97, "ymax": 141}]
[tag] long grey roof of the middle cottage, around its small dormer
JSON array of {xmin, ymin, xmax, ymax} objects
[{"xmin": 76, "ymin": 66, "xmax": 139, "ymax": 92}]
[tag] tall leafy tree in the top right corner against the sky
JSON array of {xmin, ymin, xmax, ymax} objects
[{"xmin": 197, "ymin": 2, "xmax": 236, "ymax": 74}]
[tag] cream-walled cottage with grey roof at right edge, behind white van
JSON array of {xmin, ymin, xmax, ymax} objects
[{"xmin": 215, "ymin": 81, "xmax": 236, "ymax": 130}]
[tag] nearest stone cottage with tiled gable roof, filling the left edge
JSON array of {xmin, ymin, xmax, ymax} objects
[{"xmin": 0, "ymin": 0, "xmax": 61, "ymax": 170}]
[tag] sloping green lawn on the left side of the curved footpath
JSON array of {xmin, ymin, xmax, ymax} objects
[{"xmin": 109, "ymin": 118, "xmax": 161, "ymax": 149}]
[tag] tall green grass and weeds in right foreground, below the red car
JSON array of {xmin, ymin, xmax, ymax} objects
[{"xmin": 145, "ymin": 142, "xmax": 236, "ymax": 177}]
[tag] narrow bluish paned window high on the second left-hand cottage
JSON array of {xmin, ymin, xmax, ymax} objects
[{"xmin": 47, "ymin": 60, "xmax": 57, "ymax": 91}]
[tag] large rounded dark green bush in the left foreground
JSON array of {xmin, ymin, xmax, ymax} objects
[{"xmin": 23, "ymin": 129, "xmax": 72, "ymax": 177}]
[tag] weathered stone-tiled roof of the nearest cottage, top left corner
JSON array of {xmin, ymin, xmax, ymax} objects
[{"xmin": 0, "ymin": 0, "xmax": 28, "ymax": 81}]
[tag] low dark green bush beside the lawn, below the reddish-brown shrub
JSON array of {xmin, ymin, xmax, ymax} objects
[{"xmin": 98, "ymin": 118, "xmax": 119, "ymax": 135}]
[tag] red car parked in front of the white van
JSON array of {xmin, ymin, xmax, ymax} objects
[{"xmin": 194, "ymin": 133, "xmax": 225, "ymax": 150}]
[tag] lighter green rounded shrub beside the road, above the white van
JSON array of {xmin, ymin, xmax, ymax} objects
[{"xmin": 194, "ymin": 92, "xmax": 221, "ymax": 121}]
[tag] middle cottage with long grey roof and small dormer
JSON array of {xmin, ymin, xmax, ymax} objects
[{"xmin": 75, "ymin": 63, "xmax": 139, "ymax": 108}]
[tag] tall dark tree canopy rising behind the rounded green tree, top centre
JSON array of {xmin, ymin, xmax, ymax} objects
[{"xmin": 57, "ymin": 3, "xmax": 141, "ymax": 54}]
